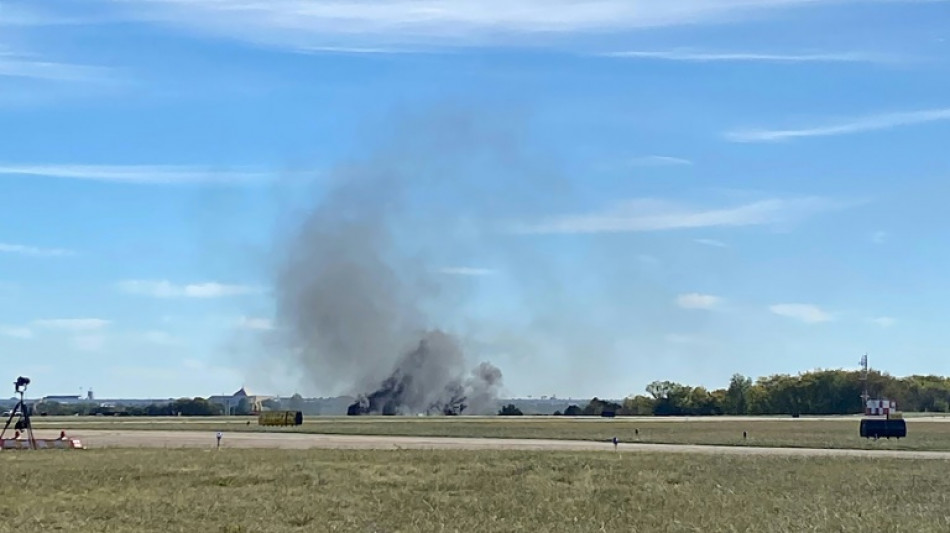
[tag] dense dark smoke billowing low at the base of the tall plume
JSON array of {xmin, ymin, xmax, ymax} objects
[{"xmin": 346, "ymin": 331, "xmax": 501, "ymax": 416}]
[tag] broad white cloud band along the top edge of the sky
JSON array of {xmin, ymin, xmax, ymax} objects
[{"xmin": 87, "ymin": 0, "xmax": 900, "ymax": 50}]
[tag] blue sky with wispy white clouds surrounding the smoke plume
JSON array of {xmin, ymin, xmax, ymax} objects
[{"xmin": 0, "ymin": 0, "xmax": 950, "ymax": 397}]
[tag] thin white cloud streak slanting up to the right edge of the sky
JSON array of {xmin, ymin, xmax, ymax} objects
[{"xmin": 725, "ymin": 107, "xmax": 950, "ymax": 142}]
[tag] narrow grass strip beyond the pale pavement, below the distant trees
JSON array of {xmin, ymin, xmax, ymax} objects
[{"xmin": 34, "ymin": 417, "xmax": 950, "ymax": 451}]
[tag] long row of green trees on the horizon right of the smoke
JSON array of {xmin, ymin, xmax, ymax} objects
[{"xmin": 555, "ymin": 370, "xmax": 950, "ymax": 416}]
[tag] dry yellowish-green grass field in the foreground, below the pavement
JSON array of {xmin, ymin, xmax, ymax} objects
[{"xmin": 0, "ymin": 450, "xmax": 950, "ymax": 533}]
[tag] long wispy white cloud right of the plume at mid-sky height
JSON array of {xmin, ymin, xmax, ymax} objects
[{"xmin": 512, "ymin": 197, "xmax": 850, "ymax": 234}]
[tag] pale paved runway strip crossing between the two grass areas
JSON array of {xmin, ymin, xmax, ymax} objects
[{"xmin": 55, "ymin": 430, "xmax": 950, "ymax": 460}]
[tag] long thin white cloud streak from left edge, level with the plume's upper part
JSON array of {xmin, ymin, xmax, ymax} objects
[{"xmin": 0, "ymin": 163, "xmax": 271, "ymax": 185}]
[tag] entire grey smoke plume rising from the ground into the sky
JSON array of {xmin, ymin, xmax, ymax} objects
[{"xmin": 274, "ymin": 110, "xmax": 501, "ymax": 414}]
